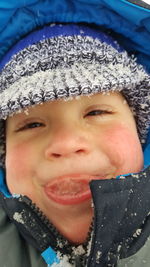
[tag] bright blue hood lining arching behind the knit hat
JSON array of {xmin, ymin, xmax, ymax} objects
[{"xmin": 0, "ymin": 0, "xmax": 150, "ymax": 184}]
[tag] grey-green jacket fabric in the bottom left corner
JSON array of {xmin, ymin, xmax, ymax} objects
[{"xmin": 0, "ymin": 203, "xmax": 46, "ymax": 267}]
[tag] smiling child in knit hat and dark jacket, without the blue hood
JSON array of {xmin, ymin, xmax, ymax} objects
[{"xmin": 0, "ymin": 24, "xmax": 150, "ymax": 267}]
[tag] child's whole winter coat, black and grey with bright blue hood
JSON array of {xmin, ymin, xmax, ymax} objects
[{"xmin": 0, "ymin": 0, "xmax": 150, "ymax": 267}]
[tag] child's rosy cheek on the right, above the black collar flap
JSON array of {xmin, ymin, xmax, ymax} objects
[{"xmin": 99, "ymin": 124, "xmax": 143, "ymax": 175}]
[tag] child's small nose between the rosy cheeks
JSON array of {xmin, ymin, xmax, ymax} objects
[{"xmin": 45, "ymin": 123, "xmax": 90, "ymax": 160}]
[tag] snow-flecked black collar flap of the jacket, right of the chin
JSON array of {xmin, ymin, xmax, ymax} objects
[{"xmin": 89, "ymin": 169, "xmax": 150, "ymax": 267}]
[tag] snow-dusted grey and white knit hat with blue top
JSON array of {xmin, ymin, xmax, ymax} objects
[{"xmin": 0, "ymin": 24, "xmax": 150, "ymax": 167}]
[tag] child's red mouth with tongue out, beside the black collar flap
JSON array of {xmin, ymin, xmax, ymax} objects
[{"xmin": 45, "ymin": 179, "xmax": 91, "ymax": 205}]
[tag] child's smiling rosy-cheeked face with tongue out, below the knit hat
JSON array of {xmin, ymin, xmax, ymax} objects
[{"xmin": 6, "ymin": 93, "xmax": 143, "ymax": 245}]
